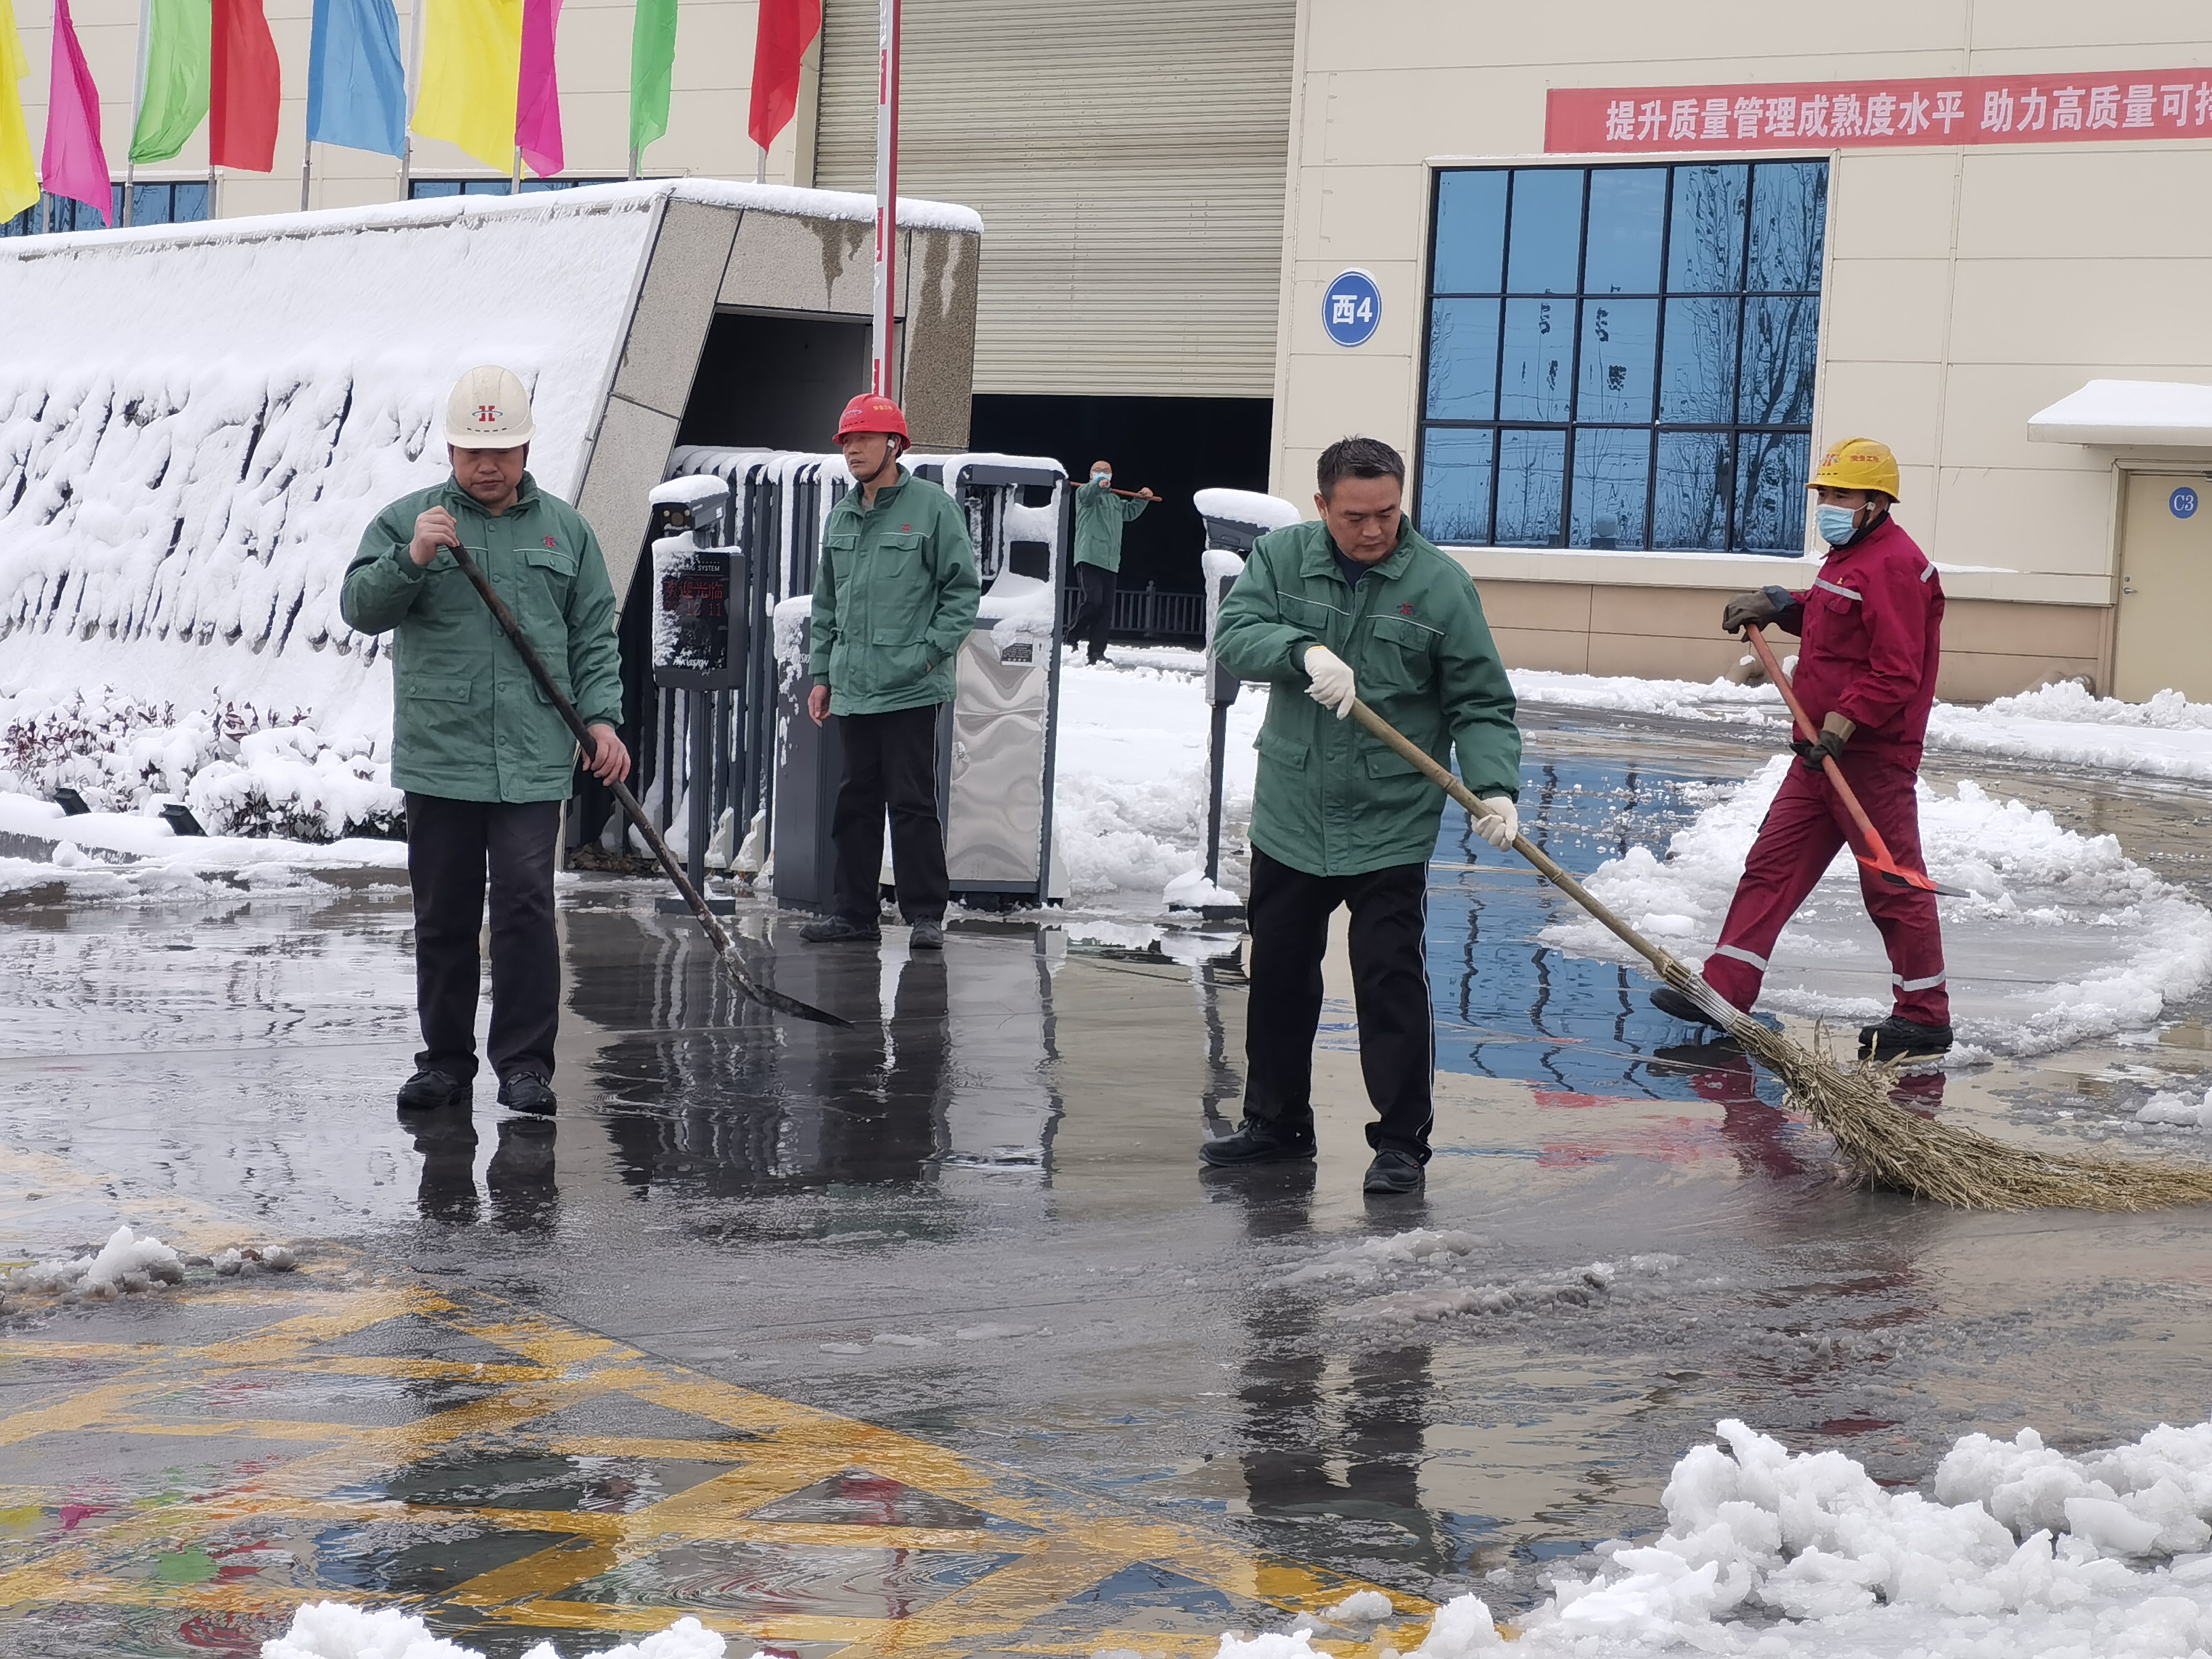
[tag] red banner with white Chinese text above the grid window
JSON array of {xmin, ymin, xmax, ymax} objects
[{"xmin": 1544, "ymin": 69, "xmax": 2212, "ymax": 155}]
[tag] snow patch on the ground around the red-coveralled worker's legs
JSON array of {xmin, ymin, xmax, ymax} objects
[{"xmin": 1542, "ymin": 754, "xmax": 2212, "ymax": 1060}]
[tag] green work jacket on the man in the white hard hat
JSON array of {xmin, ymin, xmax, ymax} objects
[{"xmin": 339, "ymin": 474, "xmax": 622, "ymax": 801}]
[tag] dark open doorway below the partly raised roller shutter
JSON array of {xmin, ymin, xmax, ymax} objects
[{"xmin": 969, "ymin": 394, "xmax": 1274, "ymax": 610}]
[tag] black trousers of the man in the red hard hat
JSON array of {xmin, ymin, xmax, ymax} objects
[{"xmin": 830, "ymin": 704, "xmax": 951, "ymax": 927}]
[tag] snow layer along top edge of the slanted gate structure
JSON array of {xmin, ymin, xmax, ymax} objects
[{"xmin": 0, "ymin": 179, "xmax": 982, "ymax": 261}]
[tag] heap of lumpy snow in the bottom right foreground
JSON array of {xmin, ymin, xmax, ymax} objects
[{"xmin": 1217, "ymin": 1420, "xmax": 2212, "ymax": 1659}]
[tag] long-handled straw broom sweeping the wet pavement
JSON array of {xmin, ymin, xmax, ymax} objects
[{"xmin": 1352, "ymin": 699, "xmax": 2212, "ymax": 1210}]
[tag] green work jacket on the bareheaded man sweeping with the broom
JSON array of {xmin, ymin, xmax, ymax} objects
[{"xmin": 1215, "ymin": 520, "xmax": 1520, "ymax": 876}]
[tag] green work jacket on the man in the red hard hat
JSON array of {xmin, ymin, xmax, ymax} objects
[{"xmin": 807, "ymin": 467, "xmax": 980, "ymax": 714}]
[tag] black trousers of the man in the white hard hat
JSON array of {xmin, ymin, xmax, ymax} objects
[{"xmin": 407, "ymin": 792, "xmax": 562, "ymax": 1082}]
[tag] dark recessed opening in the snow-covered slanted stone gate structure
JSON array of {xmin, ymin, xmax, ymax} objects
[{"xmin": 677, "ymin": 312, "xmax": 867, "ymax": 454}]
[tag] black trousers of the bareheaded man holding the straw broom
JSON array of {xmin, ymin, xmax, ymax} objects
[{"xmin": 1245, "ymin": 847, "xmax": 1435, "ymax": 1163}]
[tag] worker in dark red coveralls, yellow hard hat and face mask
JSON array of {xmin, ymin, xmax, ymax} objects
[{"xmin": 1653, "ymin": 438, "xmax": 1951, "ymax": 1060}]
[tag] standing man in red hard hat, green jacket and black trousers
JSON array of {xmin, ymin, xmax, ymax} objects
[{"xmin": 799, "ymin": 392, "xmax": 980, "ymax": 951}]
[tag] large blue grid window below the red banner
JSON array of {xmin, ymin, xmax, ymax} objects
[{"xmin": 1415, "ymin": 161, "xmax": 1827, "ymax": 553}]
